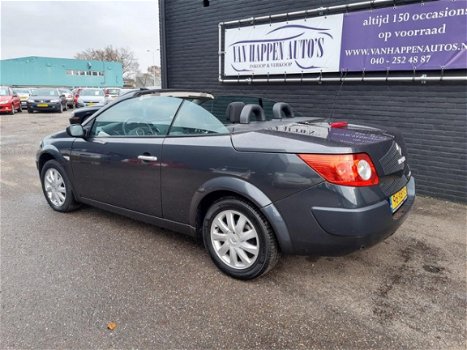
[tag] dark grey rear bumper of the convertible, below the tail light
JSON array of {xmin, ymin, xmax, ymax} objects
[{"xmin": 273, "ymin": 177, "xmax": 415, "ymax": 255}]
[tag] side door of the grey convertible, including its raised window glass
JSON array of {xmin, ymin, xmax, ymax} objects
[{"xmin": 70, "ymin": 95, "xmax": 182, "ymax": 217}]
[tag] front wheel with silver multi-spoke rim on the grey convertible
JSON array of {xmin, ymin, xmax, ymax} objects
[{"xmin": 41, "ymin": 159, "xmax": 79, "ymax": 213}]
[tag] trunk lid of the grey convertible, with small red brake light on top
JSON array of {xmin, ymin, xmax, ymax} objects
[{"xmin": 232, "ymin": 118, "xmax": 410, "ymax": 195}]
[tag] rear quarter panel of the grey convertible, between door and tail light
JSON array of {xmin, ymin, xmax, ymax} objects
[{"xmin": 161, "ymin": 135, "xmax": 323, "ymax": 223}]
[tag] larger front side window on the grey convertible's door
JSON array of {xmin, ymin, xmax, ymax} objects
[{"xmin": 91, "ymin": 95, "xmax": 182, "ymax": 137}]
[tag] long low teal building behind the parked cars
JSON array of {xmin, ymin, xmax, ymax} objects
[{"xmin": 0, "ymin": 56, "xmax": 123, "ymax": 88}]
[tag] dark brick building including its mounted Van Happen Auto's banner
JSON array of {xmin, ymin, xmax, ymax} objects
[{"xmin": 159, "ymin": 0, "xmax": 467, "ymax": 202}]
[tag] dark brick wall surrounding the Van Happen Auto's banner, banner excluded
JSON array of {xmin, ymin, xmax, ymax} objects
[{"xmin": 161, "ymin": 0, "xmax": 467, "ymax": 202}]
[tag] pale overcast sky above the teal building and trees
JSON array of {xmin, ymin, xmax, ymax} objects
[{"xmin": 0, "ymin": 0, "xmax": 160, "ymax": 72}]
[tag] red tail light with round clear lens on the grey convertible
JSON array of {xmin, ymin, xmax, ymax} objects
[{"xmin": 298, "ymin": 153, "xmax": 379, "ymax": 187}]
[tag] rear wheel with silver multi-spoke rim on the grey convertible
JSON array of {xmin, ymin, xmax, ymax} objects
[{"xmin": 203, "ymin": 197, "xmax": 280, "ymax": 280}]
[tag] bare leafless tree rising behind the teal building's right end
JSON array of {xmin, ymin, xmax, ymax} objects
[{"xmin": 75, "ymin": 46, "xmax": 139, "ymax": 76}]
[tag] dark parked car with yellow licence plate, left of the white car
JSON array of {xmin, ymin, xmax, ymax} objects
[{"xmin": 28, "ymin": 88, "xmax": 68, "ymax": 113}]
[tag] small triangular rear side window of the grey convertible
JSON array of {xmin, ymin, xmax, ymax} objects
[{"xmin": 169, "ymin": 101, "xmax": 229, "ymax": 136}]
